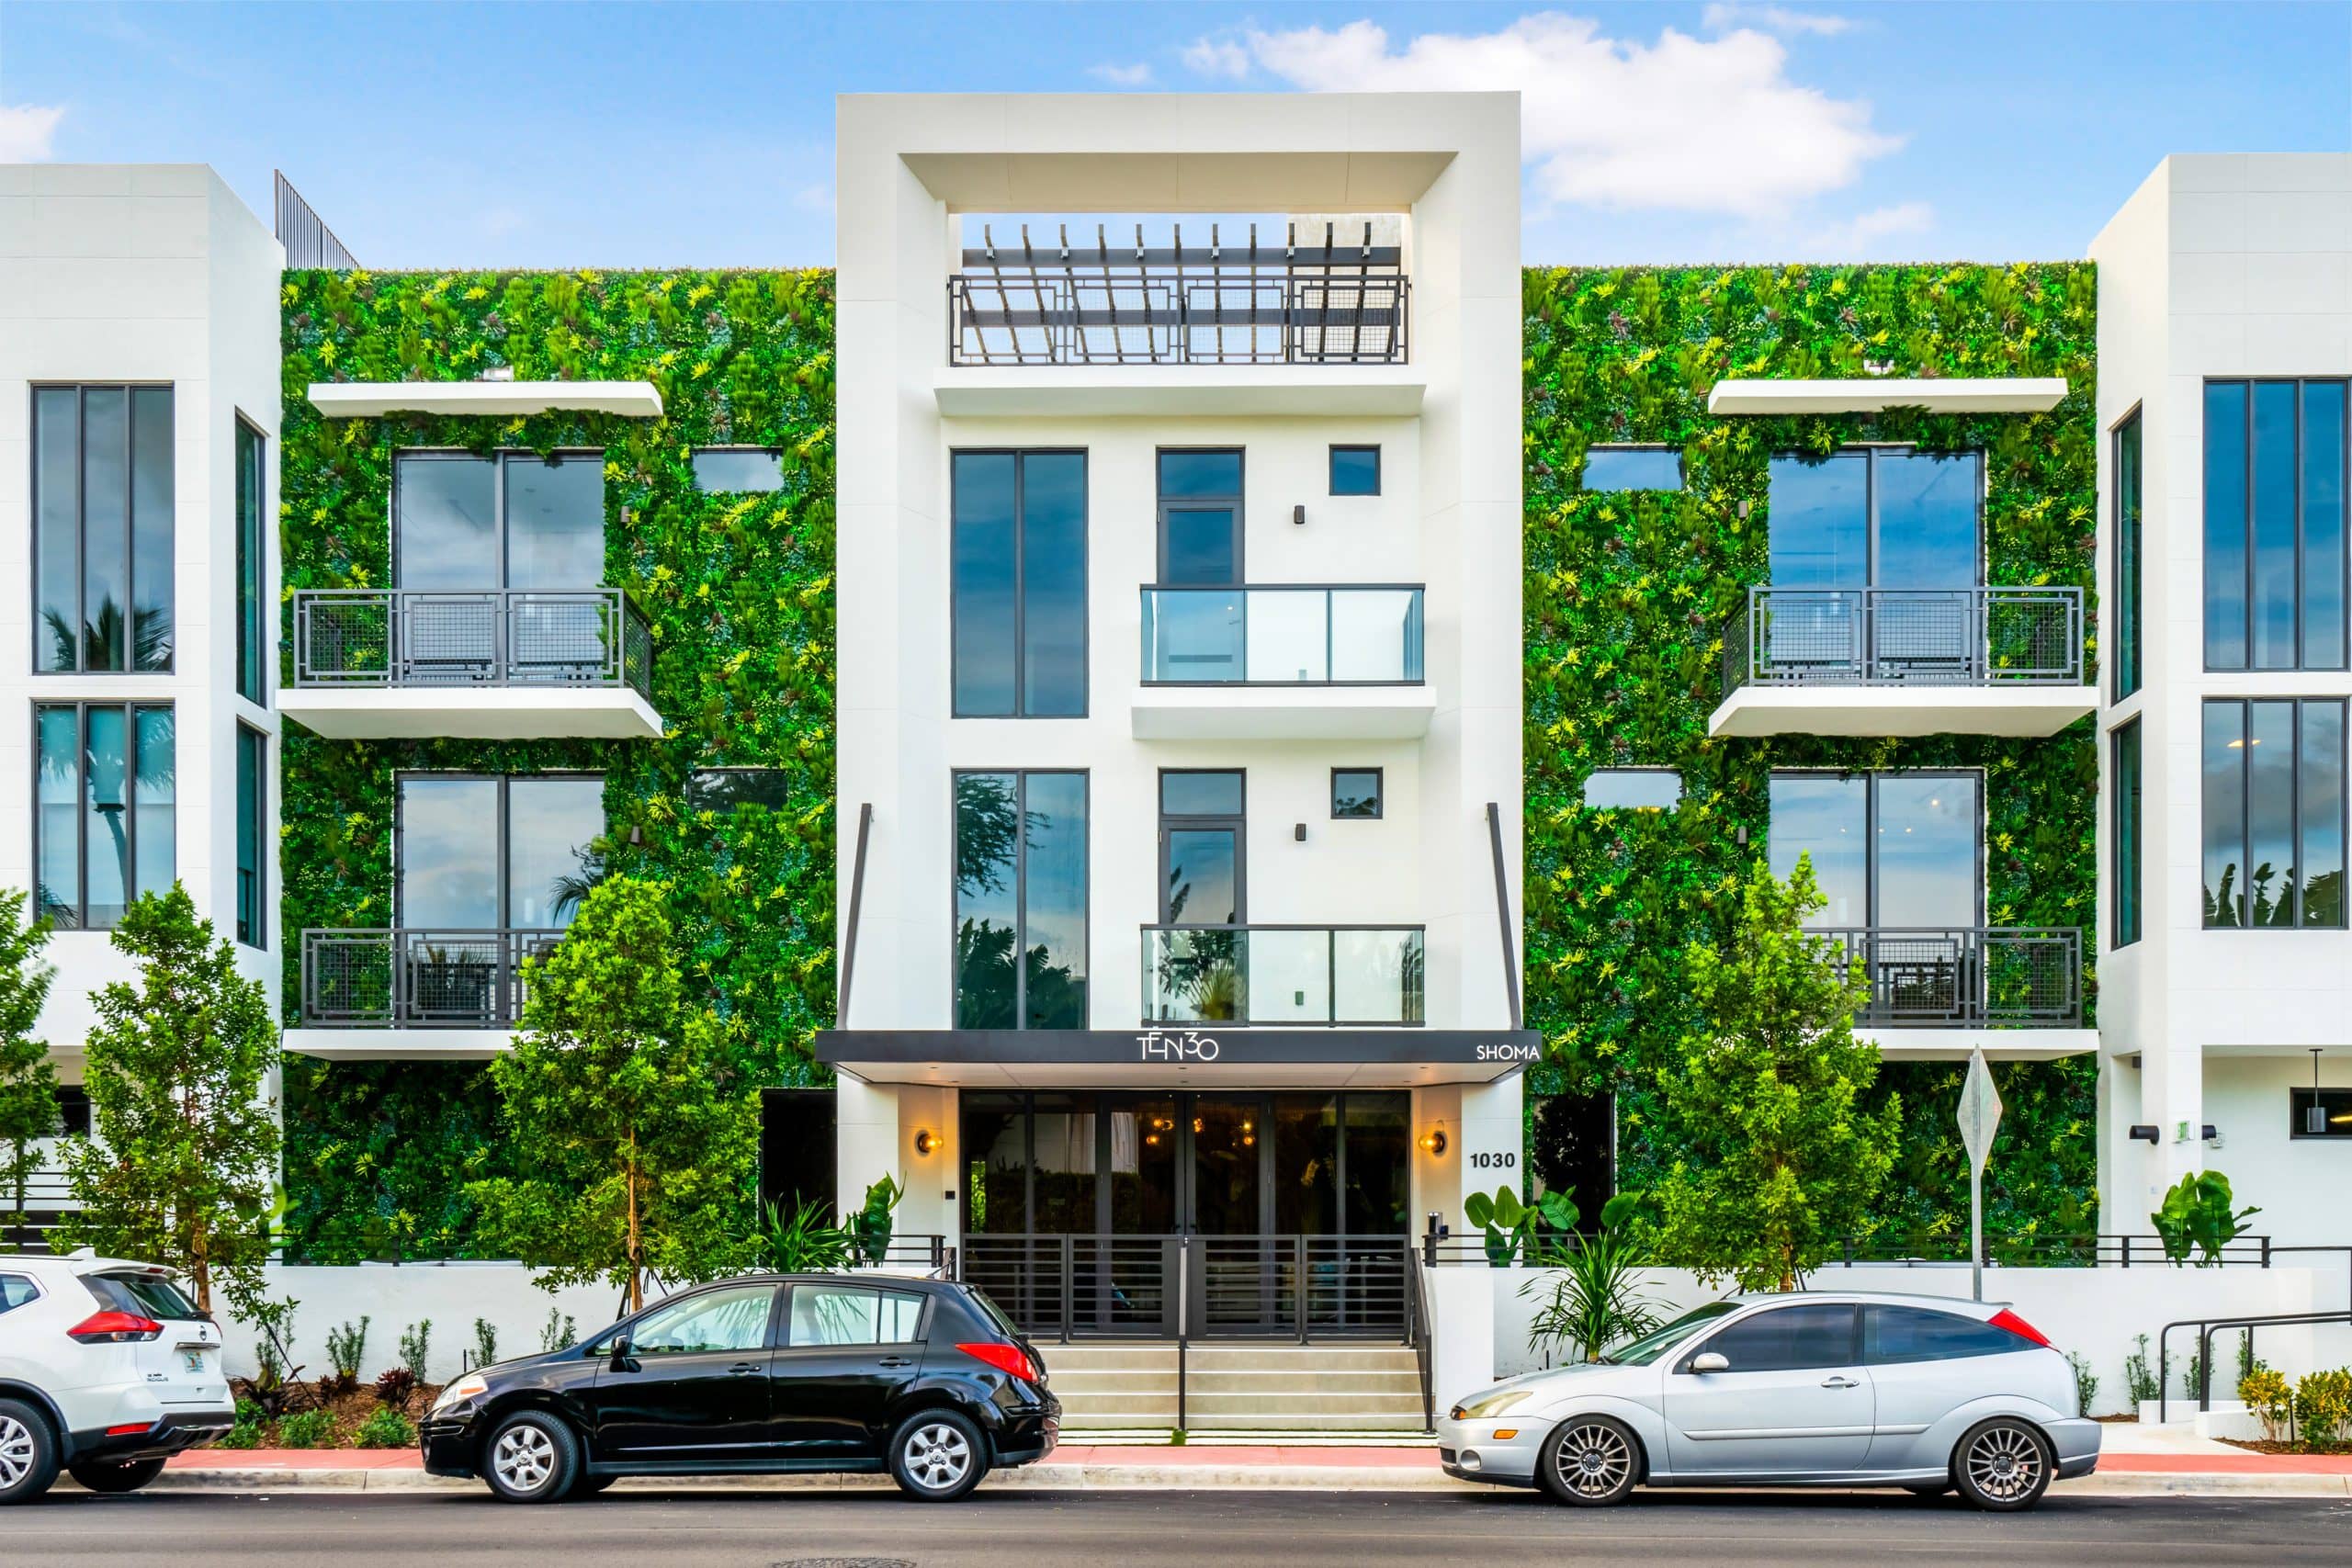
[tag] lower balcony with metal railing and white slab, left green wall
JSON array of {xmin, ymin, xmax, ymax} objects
[{"xmin": 287, "ymin": 929, "xmax": 562, "ymax": 1060}]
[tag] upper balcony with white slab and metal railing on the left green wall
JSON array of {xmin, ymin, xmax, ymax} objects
[{"xmin": 291, "ymin": 588, "xmax": 661, "ymax": 740}]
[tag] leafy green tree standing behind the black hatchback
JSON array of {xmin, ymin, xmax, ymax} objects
[{"xmin": 468, "ymin": 877, "xmax": 757, "ymax": 1309}]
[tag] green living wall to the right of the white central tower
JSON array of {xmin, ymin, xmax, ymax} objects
[{"xmin": 1524, "ymin": 264, "xmax": 2098, "ymax": 1246}]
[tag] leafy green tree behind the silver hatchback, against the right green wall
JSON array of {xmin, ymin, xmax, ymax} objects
[{"xmin": 1656, "ymin": 858, "xmax": 1903, "ymax": 1291}]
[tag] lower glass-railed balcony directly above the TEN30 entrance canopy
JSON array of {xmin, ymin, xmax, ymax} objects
[{"xmin": 1143, "ymin": 926, "xmax": 1423, "ymax": 1027}]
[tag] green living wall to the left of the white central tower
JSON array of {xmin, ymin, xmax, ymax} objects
[{"xmin": 280, "ymin": 270, "xmax": 835, "ymax": 1262}]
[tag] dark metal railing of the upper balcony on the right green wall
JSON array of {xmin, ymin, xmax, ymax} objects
[{"xmin": 1724, "ymin": 588, "xmax": 2082, "ymax": 696}]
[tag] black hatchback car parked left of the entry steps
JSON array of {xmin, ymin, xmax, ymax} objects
[{"xmin": 419, "ymin": 1274, "xmax": 1061, "ymax": 1502}]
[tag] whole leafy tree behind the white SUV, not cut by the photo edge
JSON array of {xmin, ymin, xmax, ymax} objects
[{"xmin": 54, "ymin": 882, "xmax": 277, "ymax": 1312}]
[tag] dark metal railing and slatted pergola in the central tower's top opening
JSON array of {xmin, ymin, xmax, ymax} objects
[{"xmin": 948, "ymin": 223, "xmax": 1411, "ymax": 365}]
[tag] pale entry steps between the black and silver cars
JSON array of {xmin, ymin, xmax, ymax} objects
[{"xmin": 1037, "ymin": 1340, "xmax": 1428, "ymax": 1437}]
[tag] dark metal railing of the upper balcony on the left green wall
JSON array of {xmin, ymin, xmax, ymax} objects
[{"xmin": 294, "ymin": 588, "xmax": 654, "ymax": 701}]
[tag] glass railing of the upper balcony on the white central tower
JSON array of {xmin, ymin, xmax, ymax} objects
[{"xmin": 1143, "ymin": 583, "xmax": 1423, "ymax": 686}]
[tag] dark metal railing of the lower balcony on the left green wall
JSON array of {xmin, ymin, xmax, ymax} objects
[{"xmin": 301, "ymin": 929, "xmax": 562, "ymax": 1030}]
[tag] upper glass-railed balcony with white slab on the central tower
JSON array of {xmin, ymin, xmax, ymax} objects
[{"xmin": 1131, "ymin": 583, "xmax": 1437, "ymax": 740}]
